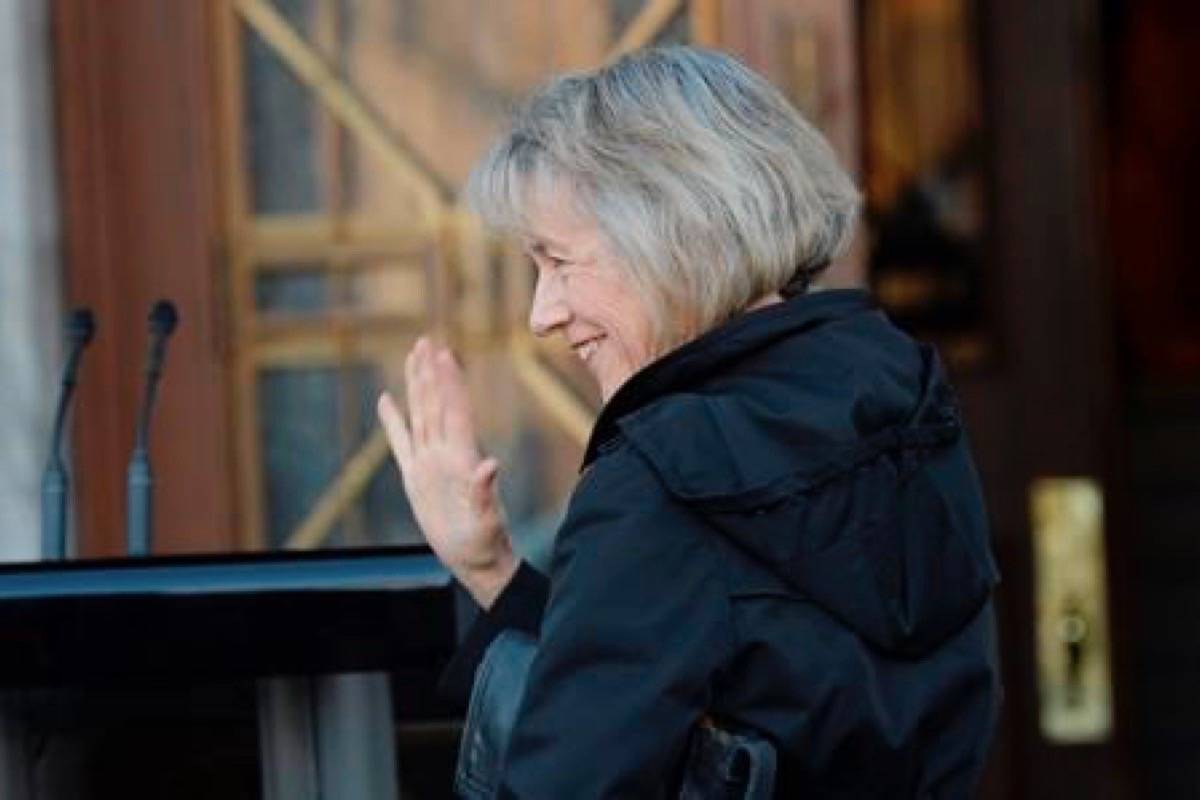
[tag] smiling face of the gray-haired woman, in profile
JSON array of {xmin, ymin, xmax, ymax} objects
[{"xmin": 524, "ymin": 192, "xmax": 654, "ymax": 402}]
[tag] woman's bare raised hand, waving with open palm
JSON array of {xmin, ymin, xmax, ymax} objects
[{"xmin": 378, "ymin": 337, "xmax": 517, "ymax": 608}]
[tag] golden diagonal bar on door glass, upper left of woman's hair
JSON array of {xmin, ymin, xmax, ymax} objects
[{"xmin": 234, "ymin": 0, "xmax": 451, "ymax": 219}]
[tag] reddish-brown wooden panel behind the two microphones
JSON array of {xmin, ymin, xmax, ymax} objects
[{"xmin": 54, "ymin": 0, "xmax": 236, "ymax": 555}]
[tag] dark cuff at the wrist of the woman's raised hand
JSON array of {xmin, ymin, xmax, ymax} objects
[{"xmin": 438, "ymin": 561, "xmax": 550, "ymax": 708}]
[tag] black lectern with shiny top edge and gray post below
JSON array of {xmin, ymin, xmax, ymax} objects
[{"xmin": 0, "ymin": 547, "xmax": 457, "ymax": 800}]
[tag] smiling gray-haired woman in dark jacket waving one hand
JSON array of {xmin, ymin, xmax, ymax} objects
[{"xmin": 379, "ymin": 48, "xmax": 998, "ymax": 799}]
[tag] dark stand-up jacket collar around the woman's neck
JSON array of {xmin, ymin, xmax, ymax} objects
[{"xmin": 581, "ymin": 289, "xmax": 875, "ymax": 469}]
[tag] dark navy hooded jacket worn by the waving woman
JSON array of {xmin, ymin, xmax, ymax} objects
[{"xmin": 444, "ymin": 290, "xmax": 1000, "ymax": 800}]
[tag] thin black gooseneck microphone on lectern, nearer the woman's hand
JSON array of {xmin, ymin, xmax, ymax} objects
[{"xmin": 125, "ymin": 300, "xmax": 179, "ymax": 555}]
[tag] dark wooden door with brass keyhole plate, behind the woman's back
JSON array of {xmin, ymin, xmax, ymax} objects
[{"xmin": 860, "ymin": 0, "xmax": 1133, "ymax": 798}]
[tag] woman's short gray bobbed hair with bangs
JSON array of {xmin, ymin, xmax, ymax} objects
[{"xmin": 467, "ymin": 47, "xmax": 859, "ymax": 347}]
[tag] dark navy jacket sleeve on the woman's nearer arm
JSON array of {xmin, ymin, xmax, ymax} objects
[{"xmin": 499, "ymin": 449, "xmax": 732, "ymax": 799}]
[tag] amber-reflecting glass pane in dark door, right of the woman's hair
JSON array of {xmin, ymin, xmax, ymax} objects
[{"xmin": 864, "ymin": 0, "xmax": 989, "ymax": 365}]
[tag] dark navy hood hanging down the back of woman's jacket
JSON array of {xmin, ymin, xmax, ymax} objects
[{"xmin": 604, "ymin": 291, "xmax": 997, "ymax": 657}]
